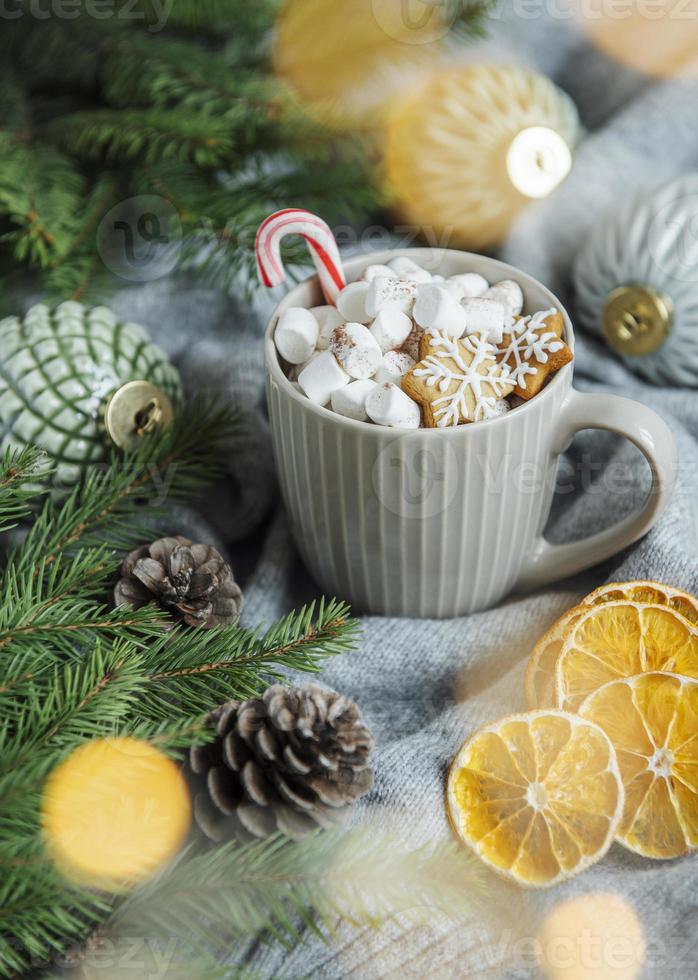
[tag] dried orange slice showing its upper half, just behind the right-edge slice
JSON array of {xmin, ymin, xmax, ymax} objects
[{"xmin": 555, "ymin": 602, "xmax": 698, "ymax": 711}]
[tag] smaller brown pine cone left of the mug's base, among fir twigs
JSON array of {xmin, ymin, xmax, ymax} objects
[{"xmin": 114, "ymin": 535, "xmax": 242, "ymax": 628}]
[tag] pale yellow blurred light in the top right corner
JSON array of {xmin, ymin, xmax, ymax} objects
[{"xmin": 575, "ymin": 0, "xmax": 698, "ymax": 78}]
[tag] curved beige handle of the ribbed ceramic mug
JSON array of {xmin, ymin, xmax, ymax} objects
[{"xmin": 516, "ymin": 389, "xmax": 678, "ymax": 591}]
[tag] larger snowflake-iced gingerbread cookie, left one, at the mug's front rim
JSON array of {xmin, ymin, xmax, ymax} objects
[{"xmin": 402, "ymin": 333, "xmax": 514, "ymax": 429}]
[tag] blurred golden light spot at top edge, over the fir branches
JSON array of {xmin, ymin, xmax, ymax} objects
[{"xmin": 273, "ymin": 0, "xmax": 457, "ymax": 126}]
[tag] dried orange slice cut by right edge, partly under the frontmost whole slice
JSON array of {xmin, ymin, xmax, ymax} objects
[{"xmin": 580, "ymin": 672, "xmax": 698, "ymax": 858}]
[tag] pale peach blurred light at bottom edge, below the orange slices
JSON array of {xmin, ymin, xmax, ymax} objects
[{"xmin": 538, "ymin": 892, "xmax": 645, "ymax": 980}]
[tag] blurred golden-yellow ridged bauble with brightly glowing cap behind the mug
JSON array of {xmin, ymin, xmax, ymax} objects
[{"xmin": 385, "ymin": 64, "xmax": 581, "ymax": 249}]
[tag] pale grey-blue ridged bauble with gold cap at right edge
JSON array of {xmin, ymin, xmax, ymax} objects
[{"xmin": 573, "ymin": 174, "xmax": 698, "ymax": 387}]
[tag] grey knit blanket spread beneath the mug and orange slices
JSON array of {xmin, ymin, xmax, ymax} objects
[{"xmin": 102, "ymin": 9, "xmax": 698, "ymax": 980}]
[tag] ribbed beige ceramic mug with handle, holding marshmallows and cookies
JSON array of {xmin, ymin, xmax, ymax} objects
[{"xmin": 265, "ymin": 248, "xmax": 676, "ymax": 617}]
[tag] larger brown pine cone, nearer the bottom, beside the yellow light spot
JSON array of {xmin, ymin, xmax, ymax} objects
[{"xmin": 190, "ymin": 684, "xmax": 373, "ymax": 841}]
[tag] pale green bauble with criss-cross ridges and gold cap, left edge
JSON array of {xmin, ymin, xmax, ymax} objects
[{"xmin": 0, "ymin": 302, "xmax": 181, "ymax": 488}]
